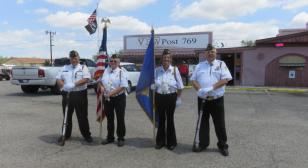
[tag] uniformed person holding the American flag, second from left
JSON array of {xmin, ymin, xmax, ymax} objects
[{"xmin": 99, "ymin": 54, "xmax": 128, "ymax": 147}]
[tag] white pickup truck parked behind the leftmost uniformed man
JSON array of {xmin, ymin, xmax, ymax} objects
[{"xmin": 11, "ymin": 58, "xmax": 96, "ymax": 94}]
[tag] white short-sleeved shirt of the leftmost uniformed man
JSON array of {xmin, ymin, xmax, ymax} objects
[{"xmin": 56, "ymin": 64, "xmax": 91, "ymax": 91}]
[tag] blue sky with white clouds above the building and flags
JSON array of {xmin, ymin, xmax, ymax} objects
[{"xmin": 0, "ymin": 0, "xmax": 308, "ymax": 58}]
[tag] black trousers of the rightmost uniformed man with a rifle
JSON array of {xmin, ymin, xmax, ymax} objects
[{"xmin": 195, "ymin": 97, "xmax": 228, "ymax": 149}]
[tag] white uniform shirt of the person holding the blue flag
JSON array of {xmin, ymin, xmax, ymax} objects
[{"xmin": 155, "ymin": 65, "xmax": 184, "ymax": 94}]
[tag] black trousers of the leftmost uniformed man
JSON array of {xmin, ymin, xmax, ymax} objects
[{"xmin": 62, "ymin": 90, "xmax": 91, "ymax": 138}]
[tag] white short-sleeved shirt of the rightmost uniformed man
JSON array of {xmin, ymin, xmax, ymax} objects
[{"xmin": 190, "ymin": 59, "xmax": 232, "ymax": 98}]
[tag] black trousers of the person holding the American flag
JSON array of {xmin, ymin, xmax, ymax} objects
[{"xmin": 104, "ymin": 93, "xmax": 126, "ymax": 141}]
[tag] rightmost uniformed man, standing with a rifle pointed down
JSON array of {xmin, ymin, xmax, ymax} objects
[{"xmin": 191, "ymin": 44, "xmax": 232, "ymax": 156}]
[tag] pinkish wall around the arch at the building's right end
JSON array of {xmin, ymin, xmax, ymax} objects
[{"xmin": 242, "ymin": 47, "xmax": 308, "ymax": 86}]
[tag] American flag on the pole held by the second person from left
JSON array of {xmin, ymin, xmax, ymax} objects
[{"xmin": 94, "ymin": 27, "xmax": 108, "ymax": 122}]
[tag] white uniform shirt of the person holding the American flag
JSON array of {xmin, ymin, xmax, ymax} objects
[{"xmin": 101, "ymin": 67, "xmax": 128, "ymax": 95}]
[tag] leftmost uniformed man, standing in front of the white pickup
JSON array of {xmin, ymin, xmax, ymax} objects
[{"xmin": 56, "ymin": 50, "xmax": 93, "ymax": 142}]
